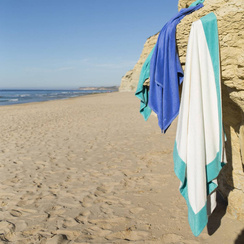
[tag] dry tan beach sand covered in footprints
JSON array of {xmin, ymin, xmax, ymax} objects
[{"xmin": 0, "ymin": 93, "xmax": 244, "ymax": 244}]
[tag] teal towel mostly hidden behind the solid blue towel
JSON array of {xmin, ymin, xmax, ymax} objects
[{"xmin": 135, "ymin": 46, "xmax": 155, "ymax": 121}]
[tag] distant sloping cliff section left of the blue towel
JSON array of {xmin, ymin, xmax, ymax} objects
[{"xmin": 119, "ymin": 34, "xmax": 158, "ymax": 91}]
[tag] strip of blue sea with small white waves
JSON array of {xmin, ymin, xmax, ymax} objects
[{"xmin": 0, "ymin": 89, "xmax": 112, "ymax": 106}]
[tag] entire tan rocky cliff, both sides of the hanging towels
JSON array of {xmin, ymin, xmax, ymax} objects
[{"xmin": 119, "ymin": 0, "xmax": 244, "ymax": 221}]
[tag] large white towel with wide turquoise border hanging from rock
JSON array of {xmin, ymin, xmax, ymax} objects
[{"xmin": 173, "ymin": 13, "xmax": 225, "ymax": 236}]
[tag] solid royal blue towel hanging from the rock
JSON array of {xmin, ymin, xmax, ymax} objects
[{"xmin": 149, "ymin": 4, "xmax": 203, "ymax": 132}]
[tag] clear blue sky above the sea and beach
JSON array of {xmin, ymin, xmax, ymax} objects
[{"xmin": 0, "ymin": 0, "xmax": 178, "ymax": 89}]
